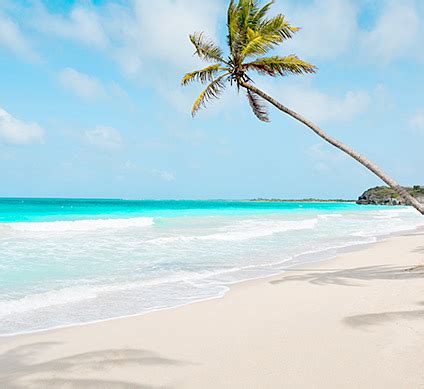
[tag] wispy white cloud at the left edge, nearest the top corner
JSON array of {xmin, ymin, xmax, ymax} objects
[{"xmin": 0, "ymin": 14, "xmax": 39, "ymax": 61}]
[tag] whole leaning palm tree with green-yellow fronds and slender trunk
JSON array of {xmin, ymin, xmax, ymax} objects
[{"xmin": 182, "ymin": 0, "xmax": 424, "ymax": 215}]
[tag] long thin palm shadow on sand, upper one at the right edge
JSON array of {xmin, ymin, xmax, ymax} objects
[{"xmin": 271, "ymin": 265, "xmax": 424, "ymax": 286}]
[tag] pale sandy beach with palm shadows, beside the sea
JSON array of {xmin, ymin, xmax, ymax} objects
[{"xmin": 0, "ymin": 232, "xmax": 424, "ymax": 389}]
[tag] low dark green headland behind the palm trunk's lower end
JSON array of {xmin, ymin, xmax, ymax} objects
[{"xmin": 356, "ymin": 185, "xmax": 424, "ymax": 205}]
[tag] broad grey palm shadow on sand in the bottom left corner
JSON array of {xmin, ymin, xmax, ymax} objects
[{"xmin": 0, "ymin": 342, "xmax": 188, "ymax": 389}]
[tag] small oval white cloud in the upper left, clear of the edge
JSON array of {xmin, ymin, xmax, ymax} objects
[{"xmin": 59, "ymin": 68, "xmax": 106, "ymax": 100}]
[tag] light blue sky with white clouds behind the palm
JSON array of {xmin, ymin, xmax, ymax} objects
[{"xmin": 0, "ymin": 0, "xmax": 424, "ymax": 199}]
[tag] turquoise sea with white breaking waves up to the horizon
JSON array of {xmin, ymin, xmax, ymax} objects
[{"xmin": 0, "ymin": 199, "xmax": 424, "ymax": 335}]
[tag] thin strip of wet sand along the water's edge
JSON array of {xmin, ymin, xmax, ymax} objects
[{"xmin": 0, "ymin": 226, "xmax": 424, "ymax": 341}]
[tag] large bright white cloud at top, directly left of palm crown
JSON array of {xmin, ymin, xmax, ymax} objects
[{"xmin": 91, "ymin": 0, "xmax": 223, "ymax": 79}]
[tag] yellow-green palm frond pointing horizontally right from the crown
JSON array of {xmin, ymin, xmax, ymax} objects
[{"xmin": 243, "ymin": 55, "xmax": 316, "ymax": 77}]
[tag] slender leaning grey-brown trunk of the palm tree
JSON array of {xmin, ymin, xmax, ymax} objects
[{"xmin": 240, "ymin": 81, "xmax": 424, "ymax": 215}]
